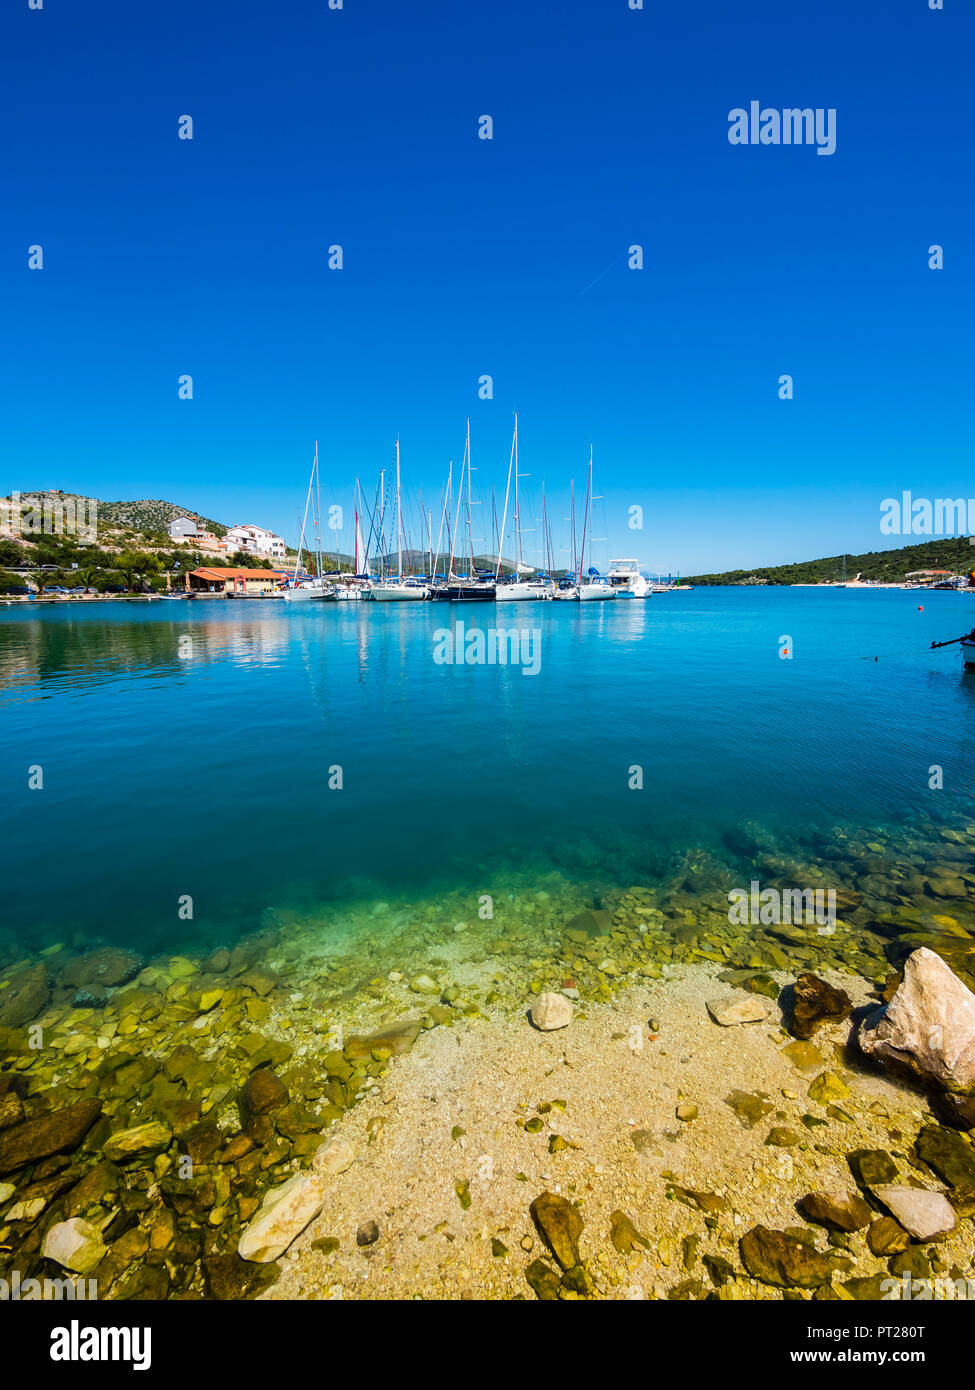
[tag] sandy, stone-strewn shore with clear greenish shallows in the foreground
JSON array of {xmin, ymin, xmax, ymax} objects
[{"xmin": 0, "ymin": 827, "xmax": 975, "ymax": 1300}]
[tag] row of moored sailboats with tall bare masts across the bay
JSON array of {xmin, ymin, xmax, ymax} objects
[{"xmin": 282, "ymin": 414, "xmax": 690, "ymax": 603}]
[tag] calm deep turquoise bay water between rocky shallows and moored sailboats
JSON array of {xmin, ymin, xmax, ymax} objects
[{"xmin": 0, "ymin": 588, "xmax": 975, "ymax": 951}]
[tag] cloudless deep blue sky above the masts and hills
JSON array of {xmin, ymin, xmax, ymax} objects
[{"xmin": 0, "ymin": 0, "xmax": 975, "ymax": 573}]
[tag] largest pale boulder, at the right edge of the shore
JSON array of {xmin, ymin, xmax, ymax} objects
[{"xmin": 858, "ymin": 947, "xmax": 975, "ymax": 1091}]
